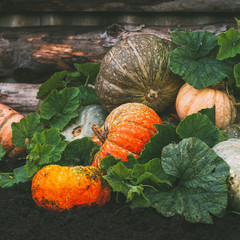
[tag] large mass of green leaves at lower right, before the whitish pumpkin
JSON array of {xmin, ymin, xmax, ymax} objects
[{"xmin": 100, "ymin": 107, "xmax": 229, "ymax": 223}]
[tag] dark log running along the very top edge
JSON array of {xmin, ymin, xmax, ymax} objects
[{"xmin": 0, "ymin": 0, "xmax": 240, "ymax": 12}]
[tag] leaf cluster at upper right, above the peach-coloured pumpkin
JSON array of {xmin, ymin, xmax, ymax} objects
[{"xmin": 170, "ymin": 19, "xmax": 240, "ymax": 96}]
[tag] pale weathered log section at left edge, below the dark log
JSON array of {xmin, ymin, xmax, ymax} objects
[{"xmin": 0, "ymin": 83, "xmax": 40, "ymax": 116}]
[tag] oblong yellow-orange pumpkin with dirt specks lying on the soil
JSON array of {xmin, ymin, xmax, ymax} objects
[{"xmin": 31, "ymin": 165, "xmax": 111, "ymax": 211}]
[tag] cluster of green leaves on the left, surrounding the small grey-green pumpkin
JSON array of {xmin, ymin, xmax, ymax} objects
[{"xmin": 0, "ymin": 63, "xmax": 100, "ymax": 187}]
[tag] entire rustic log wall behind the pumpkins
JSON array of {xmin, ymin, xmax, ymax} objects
[{"xmin": 0, "ymin": 0, "xmax": 240, "ymax": 114}]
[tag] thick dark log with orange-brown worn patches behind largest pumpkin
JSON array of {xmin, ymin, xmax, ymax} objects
[{"xmin": 0, "ymin": 24, "xmax": 232, "ymax": 83}]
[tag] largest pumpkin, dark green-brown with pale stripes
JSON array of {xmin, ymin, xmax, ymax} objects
[{"xmin": 95, "ymin": 34, "xmax": 182, "ymax": 113}]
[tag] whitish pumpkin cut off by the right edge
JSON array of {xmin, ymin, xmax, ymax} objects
[{"xmin": 213, "ymin": 138, "xmax": 240, "ymax": 210}]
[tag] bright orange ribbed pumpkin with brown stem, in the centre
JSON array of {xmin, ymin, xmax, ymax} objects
[{"xmin": 92, "ymin": 103, "xmax": 162, "ymax": 166}]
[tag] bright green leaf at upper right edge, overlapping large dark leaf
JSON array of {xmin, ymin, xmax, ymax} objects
[{"xmin": 217, "ymin": 28, "xmax": 240, "ymax": 60}]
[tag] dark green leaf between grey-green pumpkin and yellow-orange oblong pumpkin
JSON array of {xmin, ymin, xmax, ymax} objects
[{"xmin": 63, "ymin": 137, "xmax": 99, "ymax": 166}]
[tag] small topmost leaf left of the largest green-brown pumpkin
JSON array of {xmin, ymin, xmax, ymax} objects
[{"xmin": 74, "ymin": 63, "xmax": 100, "ymax": 86}]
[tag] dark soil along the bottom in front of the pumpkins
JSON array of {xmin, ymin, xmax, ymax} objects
[{"xmin": 0, "ymin": 156, "xmax": 240, "ymax": 240}]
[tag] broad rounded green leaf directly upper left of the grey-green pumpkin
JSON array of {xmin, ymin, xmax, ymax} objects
[{"xmin": 40, "ymin": 88, "xmax": 79, "ymax": 130}]
